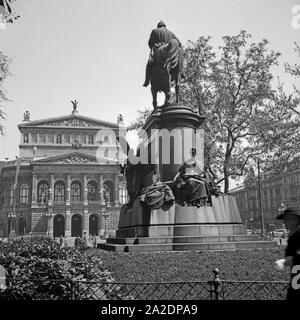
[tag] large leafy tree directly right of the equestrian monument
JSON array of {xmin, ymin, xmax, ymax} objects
[{"xmin": 183, "ymin": 31, "xmax": 299, "ymax": 192}]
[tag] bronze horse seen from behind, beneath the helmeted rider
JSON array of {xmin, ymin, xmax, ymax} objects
[{"xmin": 150, "ymin": 39, "xmax": 183, "ymax": 109}]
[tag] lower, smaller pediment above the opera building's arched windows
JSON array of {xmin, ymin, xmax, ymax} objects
[{"xmin": 33, "ymin": 152, "xmax": 117, "ymax": 165}]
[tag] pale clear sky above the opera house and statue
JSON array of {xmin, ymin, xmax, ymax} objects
[{"xmin": 0, "ymin": 0, "xmax": 300, "ymax": 160}]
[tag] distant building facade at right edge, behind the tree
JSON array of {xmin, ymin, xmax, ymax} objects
[{"xmin": 230, "ymin": 159, "xmax": 300, "ymax": 230}]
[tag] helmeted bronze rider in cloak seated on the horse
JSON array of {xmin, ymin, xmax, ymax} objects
[{"xmin": 143, "ymin": 21, "xmax": 181, "ymax": 87}]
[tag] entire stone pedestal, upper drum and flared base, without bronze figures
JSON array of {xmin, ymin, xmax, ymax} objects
[{"xmin": 100, "ymin": 105, "xmax": 274, "ymax": 252}]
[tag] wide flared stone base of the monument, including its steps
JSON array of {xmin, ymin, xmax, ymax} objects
[{"xmin": 98, "ymin": 195, "xmax": 277, "ymax": 252}]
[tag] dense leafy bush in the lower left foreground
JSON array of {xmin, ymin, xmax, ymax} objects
[{"xmin": 0, "ymin": 237, "xmax": 122, "ymax": 299}]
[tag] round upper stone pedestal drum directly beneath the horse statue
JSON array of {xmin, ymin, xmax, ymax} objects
[{"xmin": 140, "ymin": 105, "xmax": 205, "ymax": 185}]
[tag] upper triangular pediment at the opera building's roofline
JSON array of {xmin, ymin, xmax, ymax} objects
[{"xmin": 19, "ymin": 115, "xmax": 118, "ymax": 129}]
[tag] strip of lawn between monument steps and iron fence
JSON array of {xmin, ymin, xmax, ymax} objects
[{"xmin": 86, "ymin": 248, "xmax": 289, "ymax": 282}]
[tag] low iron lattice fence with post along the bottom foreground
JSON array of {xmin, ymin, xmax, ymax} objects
[{"xmin": 0, "ymin": 270, "xmax": 289, "ymax": 300}]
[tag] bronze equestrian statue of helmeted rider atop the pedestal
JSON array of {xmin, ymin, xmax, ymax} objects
[{"xmin": 143, "ymin": 21, "xmax": 184, "ymax": 109}]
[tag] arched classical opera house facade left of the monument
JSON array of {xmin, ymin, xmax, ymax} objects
[{"xmin": 0, "ymin": 105, "xmax": 127, "ymax": 237}]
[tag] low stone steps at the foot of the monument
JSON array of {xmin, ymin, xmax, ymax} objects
[{"xmin": 97, "ymin": 238, "xmax": 277, "ymax": 252}]
